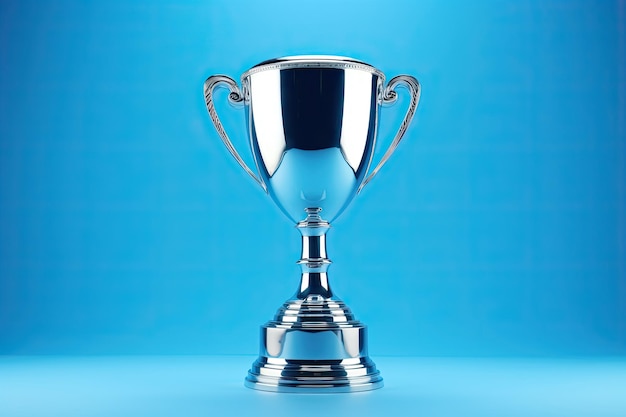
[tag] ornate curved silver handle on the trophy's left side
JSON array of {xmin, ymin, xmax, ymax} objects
[{"xmin": 204, "ymin": 75, "xmax": 267, "ymax": 192}]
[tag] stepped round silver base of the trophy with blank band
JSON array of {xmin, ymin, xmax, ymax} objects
[{"xmin": 245, "ymin": 297, "xmax": 383, "ymax": 393}]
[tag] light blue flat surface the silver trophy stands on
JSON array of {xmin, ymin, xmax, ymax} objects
[{"xmin": 0, "ymin": 356, "xmax": 626, "ymax": 417}]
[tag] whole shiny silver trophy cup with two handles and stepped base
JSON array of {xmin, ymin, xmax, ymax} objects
[{"xmin": 204, "ymin": 56, "xmax": 420, "ymax": 392}]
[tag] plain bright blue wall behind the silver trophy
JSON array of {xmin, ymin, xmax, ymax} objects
[{"xmin": 0, "ymin": 0, "xmax": 626, "ymax": 358}]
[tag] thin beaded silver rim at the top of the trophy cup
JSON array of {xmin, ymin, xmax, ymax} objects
[{"xmin": 241, "ymin": 55, "xmax": 385, "ymax": 82}]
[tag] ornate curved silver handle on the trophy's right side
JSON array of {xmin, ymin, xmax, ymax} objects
[{"xmin": 357, "ymin": 75, "xmax": 420, "ymax": 194}]
